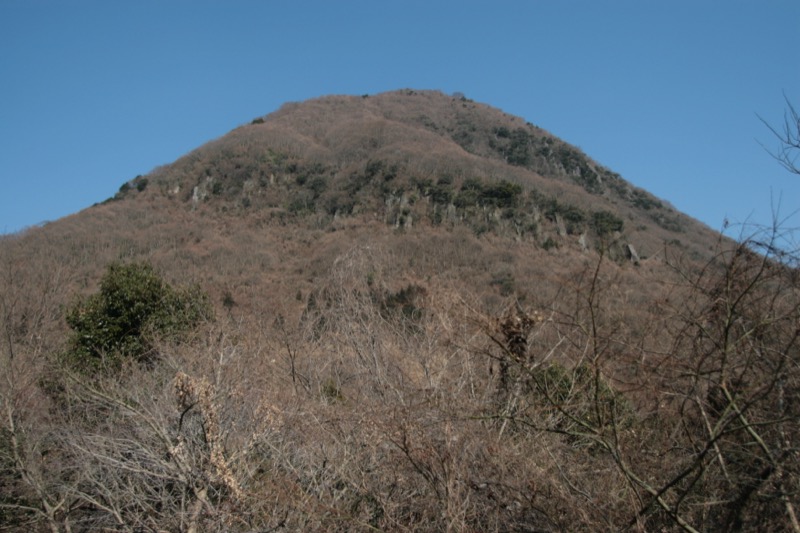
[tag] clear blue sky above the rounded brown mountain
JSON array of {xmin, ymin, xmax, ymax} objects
[{"xmin": 0, "ymin": 0, "xmax": 800, "ymax": 233}]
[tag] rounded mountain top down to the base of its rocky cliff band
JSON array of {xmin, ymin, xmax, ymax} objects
[{"xmin": 117, "ymin": 90, "xmax": 713, "ymax": 256}]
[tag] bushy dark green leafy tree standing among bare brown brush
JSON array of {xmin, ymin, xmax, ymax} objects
[{"xmin": 65, "ymin": 263, "xmax": 212, "ymax": 373}]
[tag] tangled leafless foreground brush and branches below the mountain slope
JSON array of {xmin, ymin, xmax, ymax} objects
[{"xmin": 0, "ymin": 222, "xmax": 800, "ymax": 531}]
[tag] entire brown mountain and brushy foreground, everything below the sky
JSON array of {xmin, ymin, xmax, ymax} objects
[{"xmin": 0, "ymin": 90, "xmax": 800, "ymax": 532}]
